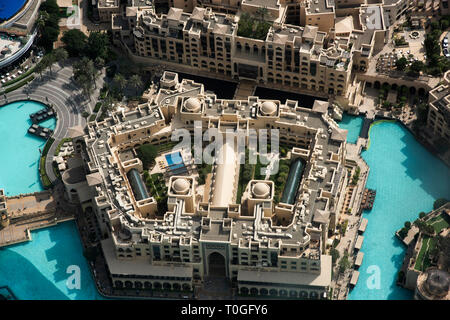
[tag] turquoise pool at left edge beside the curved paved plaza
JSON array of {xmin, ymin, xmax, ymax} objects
[{"xmin": 0, "ymin": 101, "xmax": 56, "ymax": 196}]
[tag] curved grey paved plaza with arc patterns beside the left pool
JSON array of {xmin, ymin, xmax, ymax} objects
[{"xmin": 0, "ymin": 64, "xmax": 104, "ymax": 182}]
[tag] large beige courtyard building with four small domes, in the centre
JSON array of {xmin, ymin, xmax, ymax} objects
[{"xmin": 63, "ymin": 72, "xmax": 347, "ymax": 299}]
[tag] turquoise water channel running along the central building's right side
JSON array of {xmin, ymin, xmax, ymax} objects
[{"xmin": 342, "ymin": 118, "xmax": 450, "ymax": 300}]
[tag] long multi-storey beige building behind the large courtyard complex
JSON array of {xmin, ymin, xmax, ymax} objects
[{"xmin": 113, "ymin": 7, "xmax": 352, "ymax": 96}]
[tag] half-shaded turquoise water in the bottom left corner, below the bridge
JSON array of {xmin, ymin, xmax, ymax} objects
[{"xmin": 0, "ymin": 221, "xmax": 102, "ymax": 300}]
